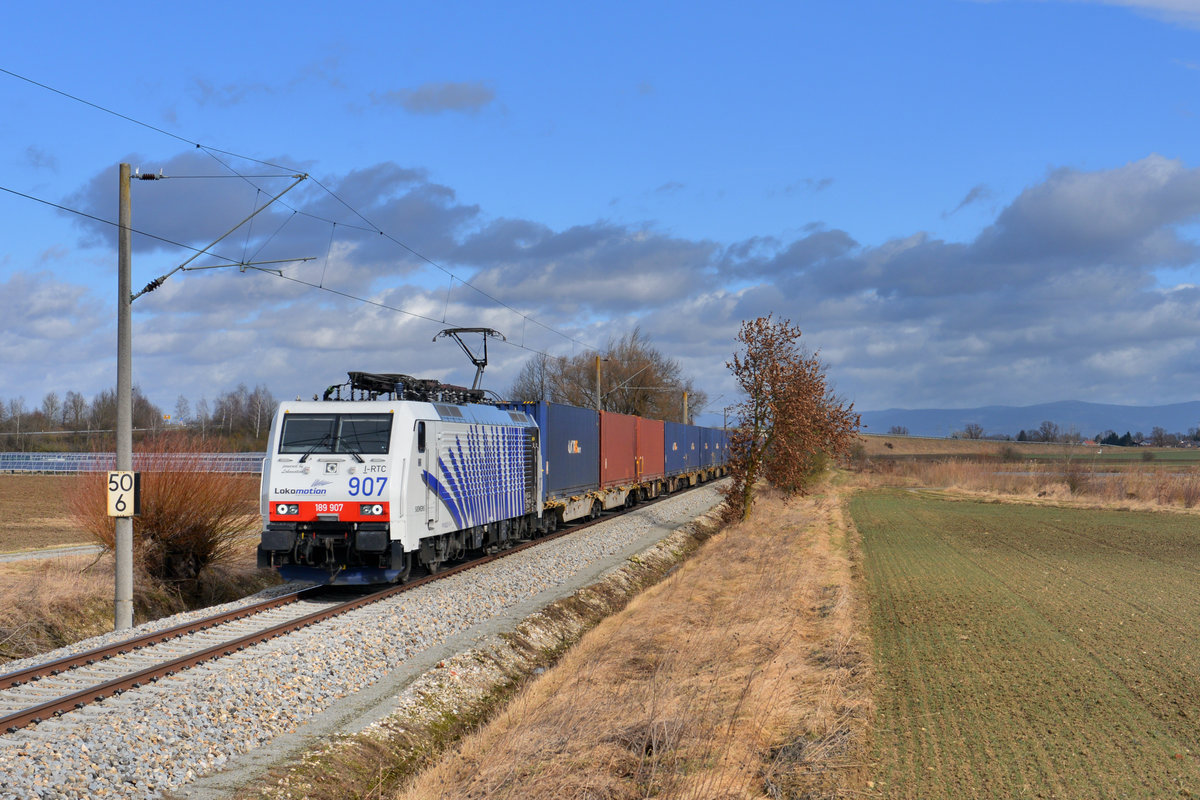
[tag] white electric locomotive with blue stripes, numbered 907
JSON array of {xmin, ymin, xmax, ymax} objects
[{"xmin": 258, "ymin": 372, "xmax": 546, "ymax": 584}]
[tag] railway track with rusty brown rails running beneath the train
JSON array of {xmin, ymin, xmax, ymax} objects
[{"xmin": 0, "ymin": 495, "xmax": 672, "ymax": 733}]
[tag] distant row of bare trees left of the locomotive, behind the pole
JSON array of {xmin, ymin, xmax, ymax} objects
[{"xmin": 0, "ymin": 384, "xmax": 276, "ymax": 452}]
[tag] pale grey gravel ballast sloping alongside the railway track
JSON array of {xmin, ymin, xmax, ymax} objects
[{"xmin": 0, "ymin": 486, "xmax": 719, "ymax": 799}]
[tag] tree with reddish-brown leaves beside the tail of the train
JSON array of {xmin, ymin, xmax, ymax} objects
[{"xmin": 726, "ymin": 315, "xmax": 859, "ymax": 519}]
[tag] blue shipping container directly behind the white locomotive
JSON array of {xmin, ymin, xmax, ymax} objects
[{"xmin": 502, "ymin": 402, "xmax": 600, "ymax": 499}]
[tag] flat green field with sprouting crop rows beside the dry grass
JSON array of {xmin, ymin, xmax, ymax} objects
[{"xmin": 851, "ymin": 492, "xmax": 1200, "ymax": 799}]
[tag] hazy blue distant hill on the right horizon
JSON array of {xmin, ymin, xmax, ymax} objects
[{"xmin": 862, "ymin": 401, "xmax": 1200, "ymax": 439}]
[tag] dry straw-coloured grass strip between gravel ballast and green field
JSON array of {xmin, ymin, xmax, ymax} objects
[{"xmin": 396, "ymin": 495, "xmax": 870, "ymax": 800}]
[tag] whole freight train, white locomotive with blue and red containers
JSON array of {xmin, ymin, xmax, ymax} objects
[{"xmin": 258, "ymin": 372, "xmax": 728, "ymax": 584}]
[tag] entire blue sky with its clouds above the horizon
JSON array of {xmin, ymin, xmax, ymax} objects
[{"xmin": 0, "ymin": 0, "xmax": 1200, "ymax": 421}]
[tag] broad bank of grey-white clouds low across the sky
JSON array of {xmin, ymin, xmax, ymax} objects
[{"xmin": 11, "ymin": 149, "xmax": 1200, "ymax": 417}]
